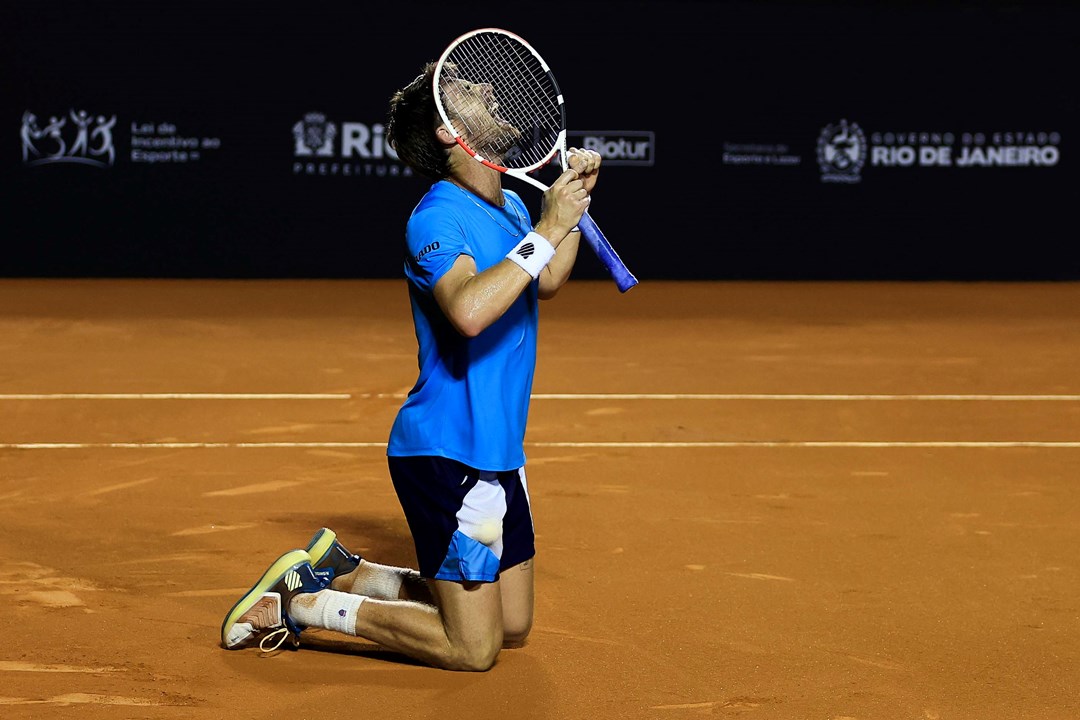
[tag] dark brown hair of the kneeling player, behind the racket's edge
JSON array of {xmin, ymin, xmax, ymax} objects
[{"xmin": 387, "ymin": 63, "xmax": 450, "ymax": 180}]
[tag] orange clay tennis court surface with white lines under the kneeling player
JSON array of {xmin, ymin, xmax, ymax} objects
[{"xmin": 0, "ymin": 280, "xmax": 1080, "ymax": 720}]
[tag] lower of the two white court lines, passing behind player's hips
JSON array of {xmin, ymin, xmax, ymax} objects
[{"xmin": 0, "ymin": 440, "xmax": 1080, "ymax": 450}]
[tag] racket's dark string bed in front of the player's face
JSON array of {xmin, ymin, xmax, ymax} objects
[{"xmin": 444, "ymin": 33, "xmax": 564, "ymax": 169}]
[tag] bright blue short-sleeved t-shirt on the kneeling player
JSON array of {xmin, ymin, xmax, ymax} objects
[{"xmin": 387, "ymin": 180, "xmax": 539, "ymax": 471}]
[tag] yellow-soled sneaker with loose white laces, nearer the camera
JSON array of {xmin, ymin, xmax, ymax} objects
[{"xmin": 221, "ymin": 549, "xmax": 334, "ymax": 652}]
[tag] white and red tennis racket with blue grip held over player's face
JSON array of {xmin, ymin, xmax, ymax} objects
[{"xmin": 432, "ymin": 28, "xmax": 637, "ymax": 293}]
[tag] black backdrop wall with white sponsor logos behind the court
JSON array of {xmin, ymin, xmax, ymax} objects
[{"xmin": 0, "ymin": 0, "xmax": 1080, "ymax": 281}]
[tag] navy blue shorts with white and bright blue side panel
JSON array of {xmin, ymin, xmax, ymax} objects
[{"xmin": 387, "ymin": 456, "xmax": 536, "ymax": 583}]
